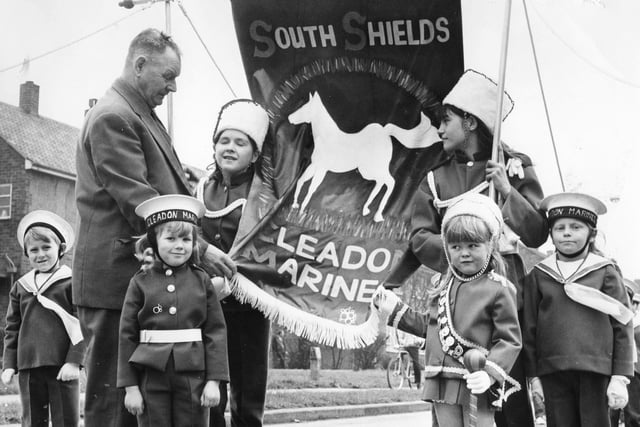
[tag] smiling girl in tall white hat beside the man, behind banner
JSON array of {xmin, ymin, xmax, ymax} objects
[{"xmin": 196, "ymin": 99, "xmax": 270, "ymax": 427}]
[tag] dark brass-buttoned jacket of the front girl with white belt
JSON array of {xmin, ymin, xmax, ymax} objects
[{"xmin": 117, "ymin": 263, "xmax": 229, "ymax": 387}]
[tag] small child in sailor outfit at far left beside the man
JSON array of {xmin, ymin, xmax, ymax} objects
[{"xmin": 2, "ymin": 210, "xmax": 84, "ymax": 427}]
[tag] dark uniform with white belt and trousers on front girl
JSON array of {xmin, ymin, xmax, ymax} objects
[{"xmin": 117, "ymin": 262, "xmax": 229, "ymax": 426}]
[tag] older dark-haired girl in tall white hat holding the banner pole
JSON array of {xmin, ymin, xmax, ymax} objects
[{"xmin": 410, "ymin": 70, "xmax": 548, "ymax": 427}]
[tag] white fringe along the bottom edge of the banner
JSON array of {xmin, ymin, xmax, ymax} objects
[{"xmin": 231, "ymin": 273, "xmax": 380, "ymax": 349}]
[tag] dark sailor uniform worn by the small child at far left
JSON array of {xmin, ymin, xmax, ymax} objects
[{"xmin": 3, "ymin": 265, "xmax": 85, "ymax": 427}]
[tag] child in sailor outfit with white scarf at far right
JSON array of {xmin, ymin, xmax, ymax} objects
[{"xmin": 523, "ymin": 193, "xmax": 635, "ymax": 427}]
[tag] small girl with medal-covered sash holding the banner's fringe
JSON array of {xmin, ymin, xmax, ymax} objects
[{"xmin": 374, "ymin": 194, "xmax": 521, "ymax": 427}]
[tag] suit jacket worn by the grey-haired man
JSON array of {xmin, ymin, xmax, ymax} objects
[{"xmin": 73, "ymin": 79, "xmax": 190, "ymax": 310}]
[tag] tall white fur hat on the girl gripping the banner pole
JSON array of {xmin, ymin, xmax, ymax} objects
[{"xmin": 442, "ymin": 70, "xmax": 513, "ymax": 133}]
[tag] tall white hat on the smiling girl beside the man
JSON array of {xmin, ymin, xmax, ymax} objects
[{"xmin": 213, "ymin": 99, "xmax": 269, "ymax": 151}]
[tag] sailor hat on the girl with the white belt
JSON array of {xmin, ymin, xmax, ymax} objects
[{"xmin": 136, "ymin": 194, "xmax": 205, "ymax": 230}]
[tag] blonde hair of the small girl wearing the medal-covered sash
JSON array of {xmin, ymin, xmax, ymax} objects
[{"xmin": 429, "ymin": 214, "xmax": 506, "ymax": 295}]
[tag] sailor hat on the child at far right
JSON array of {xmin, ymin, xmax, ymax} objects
[{"xmin": 540, "ymin": 193, "xmax": 607, "ymax": 227}]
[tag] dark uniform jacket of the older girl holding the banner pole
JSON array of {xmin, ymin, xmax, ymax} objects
[{"xmin": 410, "ymin": 150, "xmax": 548, "ymax": 283}]
